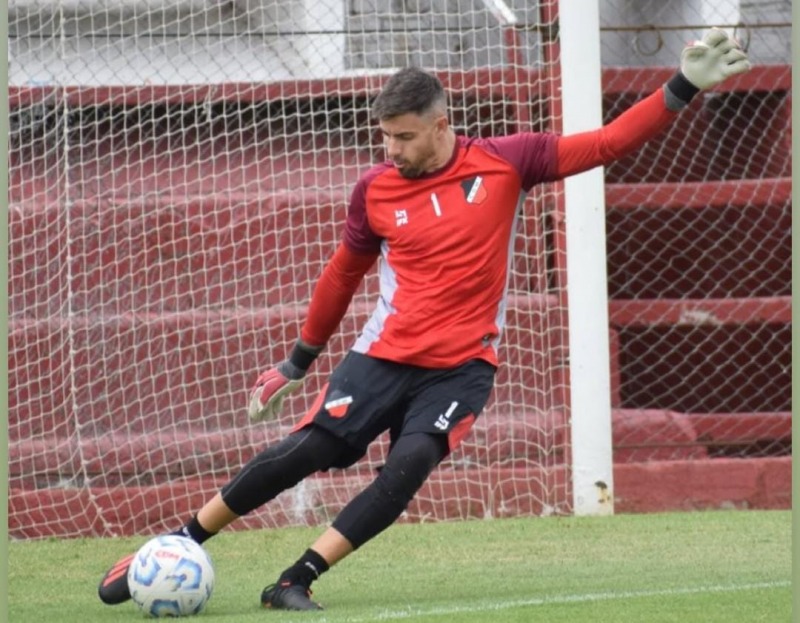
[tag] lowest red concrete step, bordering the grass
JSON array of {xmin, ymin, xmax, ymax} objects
[{"xmin": 8, "ymin": 457, "xmax": 792, "ymax": 539}]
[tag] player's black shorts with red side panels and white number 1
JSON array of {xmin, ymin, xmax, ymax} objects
[{"xmin": 294, "ymin": 351, "xmax": 495, "ymax": 467}]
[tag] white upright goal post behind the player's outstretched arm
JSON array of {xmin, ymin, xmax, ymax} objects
[{"xmin": 559, "ymin": 1, "xmax": 614, "ymax": 515}]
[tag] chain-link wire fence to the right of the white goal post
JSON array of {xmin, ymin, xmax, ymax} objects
[{"xmin": 601, "ymin": 0, "xmax": 791, "ymax": 461}]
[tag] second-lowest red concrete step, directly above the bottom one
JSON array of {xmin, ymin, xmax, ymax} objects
[{"xmin": 9, "ymin": 405, "xmax": 791, "ymax": 489}]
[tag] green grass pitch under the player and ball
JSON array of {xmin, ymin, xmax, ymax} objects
[{"xmin": 8, "ymin": 511, "xmax": 791, "ymax": 623}]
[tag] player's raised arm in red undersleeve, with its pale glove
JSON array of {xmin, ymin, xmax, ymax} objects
[{"xmin": 556, "ymin": 28, "xmax": 750, "ymax": 179}]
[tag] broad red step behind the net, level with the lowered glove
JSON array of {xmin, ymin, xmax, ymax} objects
[{"xmin": 8, "ymin": 294, "xmax": 566, "ymax": 439}]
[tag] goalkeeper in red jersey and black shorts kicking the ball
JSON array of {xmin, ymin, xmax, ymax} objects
[{"xmin": 99, "ymin": 29, "xmax": 749, "ymax": 610}]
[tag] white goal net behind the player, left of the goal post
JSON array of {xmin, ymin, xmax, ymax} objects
[{"xmin": 9, "ymin": 0, "xmax": 570, "ymax": 536}]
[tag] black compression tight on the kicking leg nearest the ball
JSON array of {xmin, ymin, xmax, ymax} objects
[{"xmin": 221, "ymin": 426, "xmax": 342, "ymax": 516}]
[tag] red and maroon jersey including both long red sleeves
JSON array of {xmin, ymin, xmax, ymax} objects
[{"xmin": 301, "ymin": 89, "xmax": 677, "ymax": 368}]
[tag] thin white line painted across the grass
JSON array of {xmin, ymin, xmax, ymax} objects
[{"xmin": 286, "ymin": 580, "xmax": 792, "ymax": 623}]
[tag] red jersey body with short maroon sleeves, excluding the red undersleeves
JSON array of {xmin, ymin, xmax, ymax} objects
[{"xmin": 344, "ymin": 133, "xmax": 556, "ymax": 368}]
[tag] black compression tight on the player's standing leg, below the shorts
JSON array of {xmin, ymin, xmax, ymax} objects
[{"xmin": 333, "ymin": 433, "xmax": 447, "ymax": 549}]
